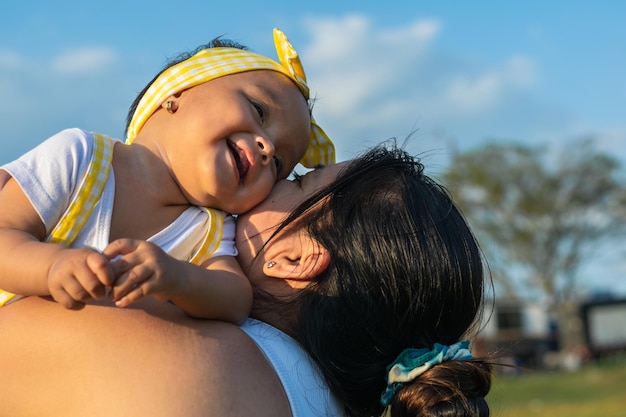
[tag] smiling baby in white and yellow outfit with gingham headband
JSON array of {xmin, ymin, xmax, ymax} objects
[{"xmin": 0, "ymin": 29, "xmax": 334, "ymax": 323}]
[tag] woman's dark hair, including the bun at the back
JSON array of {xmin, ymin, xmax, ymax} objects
[{"xmin": 260, "ymin": 143, "xmax": 491, "ymax": 417}]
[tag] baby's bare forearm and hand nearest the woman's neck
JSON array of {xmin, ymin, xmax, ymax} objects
[{"xmin": 103, "ymin": 239, "xmax": 252, "ymax": 324}]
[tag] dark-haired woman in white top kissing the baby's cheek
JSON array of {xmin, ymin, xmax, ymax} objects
[{"xmin": 0, "ymin": 147, "xmax": 491, "ymax": 417}]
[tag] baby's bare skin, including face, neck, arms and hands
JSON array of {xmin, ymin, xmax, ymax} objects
[{"xmin": 0, "ymin": 70, "xmax": 310, "ymax": 323}]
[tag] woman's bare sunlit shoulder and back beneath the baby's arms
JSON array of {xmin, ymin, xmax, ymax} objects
[{"xmin": 0, "ymin": 297, "xmax": 291, "ymax": 416}]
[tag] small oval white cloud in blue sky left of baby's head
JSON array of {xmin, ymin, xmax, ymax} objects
[{"xmin": 52, "ymin": 47, "xmax": 116, "ymax": 74}]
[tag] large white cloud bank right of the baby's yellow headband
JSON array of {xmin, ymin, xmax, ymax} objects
[{"xmin": 301, "ymin": 15, "xmax": 540, "ymax": 157}]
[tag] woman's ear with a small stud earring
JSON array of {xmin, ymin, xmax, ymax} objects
[{"xmin": 263, "ymin": 233, "xmax": 330, "ymax": 288}]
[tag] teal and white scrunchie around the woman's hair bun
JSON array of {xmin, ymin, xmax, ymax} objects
[{"xmin": 380, "ymin": 340, "xmax": 473, "ymax": 407}]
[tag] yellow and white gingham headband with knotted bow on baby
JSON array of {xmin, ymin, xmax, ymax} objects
[{"xmin": 126, "ymin": 29, "xmax": 335, "ymax": 168}]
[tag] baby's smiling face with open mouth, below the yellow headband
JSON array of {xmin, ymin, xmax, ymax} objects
[{"xmin": 168, "ymin": 70, "xmax": 311, "ymax": 214}]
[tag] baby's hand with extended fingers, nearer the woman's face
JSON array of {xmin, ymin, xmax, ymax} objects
[{"xmin": 102, "ymin": 239, "xmax": 181, "ymax": 307}]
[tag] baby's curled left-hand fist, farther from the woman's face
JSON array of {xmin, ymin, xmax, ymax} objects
[{"xmin": 48, "ymin": 248, "xmax": 114, "ymax": 309}]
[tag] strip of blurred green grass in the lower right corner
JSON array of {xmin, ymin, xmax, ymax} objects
[{"xmin": 487, "ymin": 360, "xmax": 626, "ymax": 417}]
